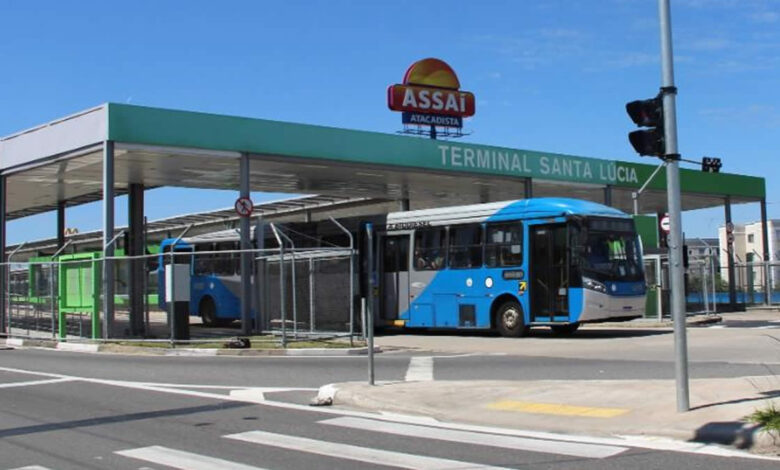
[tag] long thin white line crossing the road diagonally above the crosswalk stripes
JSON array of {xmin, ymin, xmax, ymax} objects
[{"xmin": 0, "ymin": 367, "xmax": 780, "ymax": 462}]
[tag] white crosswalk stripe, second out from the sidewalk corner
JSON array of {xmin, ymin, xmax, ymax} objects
[{"xmin": 223, "ymin": 431, "xmax": 507, "ymax": 470}]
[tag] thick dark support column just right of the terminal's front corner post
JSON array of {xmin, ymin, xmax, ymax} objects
[{"xmin": 126, "ymin": 184, "xmax": 146, "ymax": 336}]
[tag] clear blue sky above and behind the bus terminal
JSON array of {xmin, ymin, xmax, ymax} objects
[{"xmin": 0, "ymin": 0, "xmax": 780, "ymax": 244}]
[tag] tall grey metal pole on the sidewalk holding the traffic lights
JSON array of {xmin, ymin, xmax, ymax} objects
[{"xmin": 658, "ymin": 0, "xmax": 690, "ymax": 412}]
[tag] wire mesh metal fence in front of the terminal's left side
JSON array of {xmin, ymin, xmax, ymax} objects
[{"xmin": 2, "ymin": 241, "xmax": 360, "ymax": 344}]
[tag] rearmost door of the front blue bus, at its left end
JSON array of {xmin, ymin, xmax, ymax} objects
[{"xmin": 379, "ymin": 235, "xmax": 409, "ymax": 320}]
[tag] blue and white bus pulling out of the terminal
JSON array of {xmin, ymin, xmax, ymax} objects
[{"xmin": 374, "ymin": 198, "xmax": 646, "ymax": 337}]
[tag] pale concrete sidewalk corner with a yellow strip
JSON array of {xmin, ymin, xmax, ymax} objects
[{"xmin": 331, "ymin": 376, "xmax": 780, "ymax": 454}]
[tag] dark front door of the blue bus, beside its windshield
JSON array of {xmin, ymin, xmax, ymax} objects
[{"xmin": 529, "ymin": 223, "xmax": 569, "ymax": 321}]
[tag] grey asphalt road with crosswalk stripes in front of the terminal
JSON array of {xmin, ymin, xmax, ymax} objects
[{"xmin": 0, "ymin": 326, "xmax": 778, "ymax": 470}]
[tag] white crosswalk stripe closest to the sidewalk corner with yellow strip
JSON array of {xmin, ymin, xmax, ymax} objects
[{"xmin": 320, "ymin": 417, "xmax": 627, "ymax": 459}]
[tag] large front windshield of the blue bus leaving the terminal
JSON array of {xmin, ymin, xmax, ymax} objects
[{"xmin": 582, "ymin": 219, "xmax": 644, "ymax": 282}]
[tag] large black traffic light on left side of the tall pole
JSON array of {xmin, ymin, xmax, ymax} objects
[{"xmin": 626, "ymin": 94, "xmax": 666, "ymax": 157}]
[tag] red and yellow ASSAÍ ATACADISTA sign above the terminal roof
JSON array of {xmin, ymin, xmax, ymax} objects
[{"xmin": 387, "ymin": 58, "xmax": 475, "ymax": 127}]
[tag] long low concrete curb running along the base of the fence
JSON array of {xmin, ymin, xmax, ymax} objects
[{"xmin": 0, "ymin": 338, "xmax": 382, "ymax": 357}]
